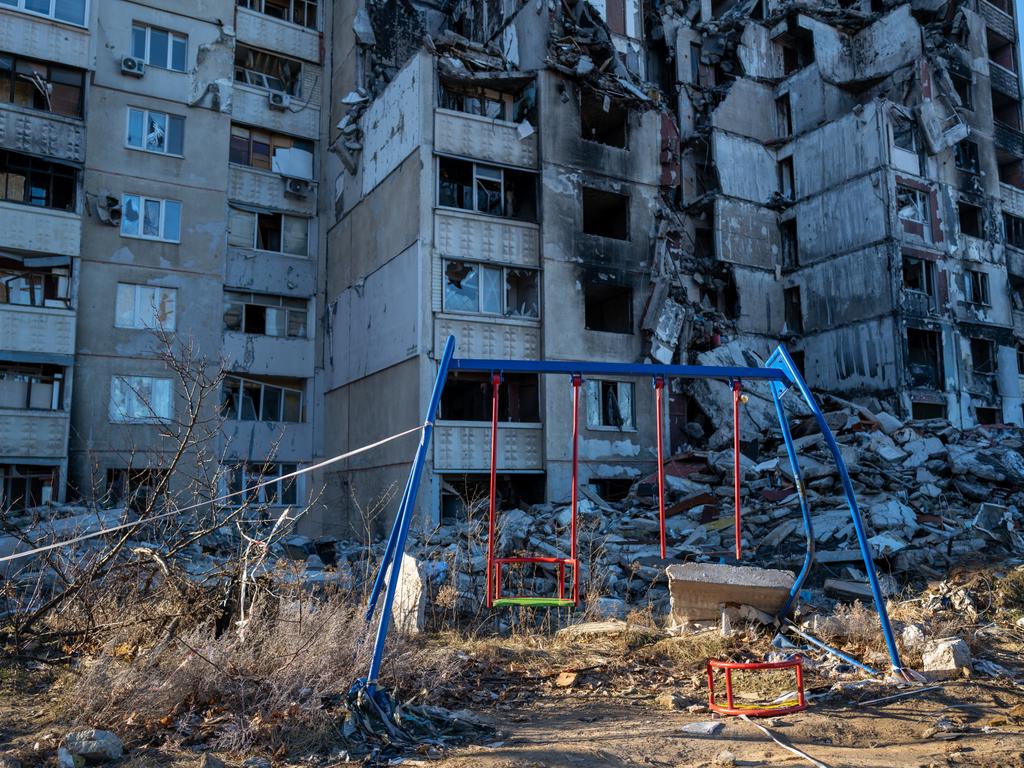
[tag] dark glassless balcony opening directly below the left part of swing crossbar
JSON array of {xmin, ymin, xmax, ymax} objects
[{"xmin": 440, "ymin": 372, "xmax": 541, "ymax": 424}]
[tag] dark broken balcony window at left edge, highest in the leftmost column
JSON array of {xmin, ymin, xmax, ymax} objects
[{"xmin": 0, "ymin": 54, "xmax": 85, "ymax": 118}]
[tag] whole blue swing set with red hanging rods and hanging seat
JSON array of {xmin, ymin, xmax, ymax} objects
[{"xmin": 356, "ymin": 336, "xmax": 906, "ymax": 693}]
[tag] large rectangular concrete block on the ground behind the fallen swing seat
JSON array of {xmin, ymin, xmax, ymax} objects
[{"xmin": 666, "ymin": 563, "xmax": 795, "ymax": 624}]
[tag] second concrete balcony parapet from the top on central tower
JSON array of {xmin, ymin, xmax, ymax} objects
[{"xmin": 434, "ymin": 210, "xmax": 541, "ymax": 266}]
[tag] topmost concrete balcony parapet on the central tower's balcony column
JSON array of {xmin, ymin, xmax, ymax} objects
[{"xmin": 434, "ymin": 110, "xmax": 537, "ymax": 168}]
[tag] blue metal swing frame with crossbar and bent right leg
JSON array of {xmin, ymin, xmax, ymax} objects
[{"xmin": 356, "ymin": 336, "xmax": 904, "ymax": 694}]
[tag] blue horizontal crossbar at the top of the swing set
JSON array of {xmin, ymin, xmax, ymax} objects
[{"xmin": 449, "ymin": 357, "xmax": 791, "ymax": 384}]
